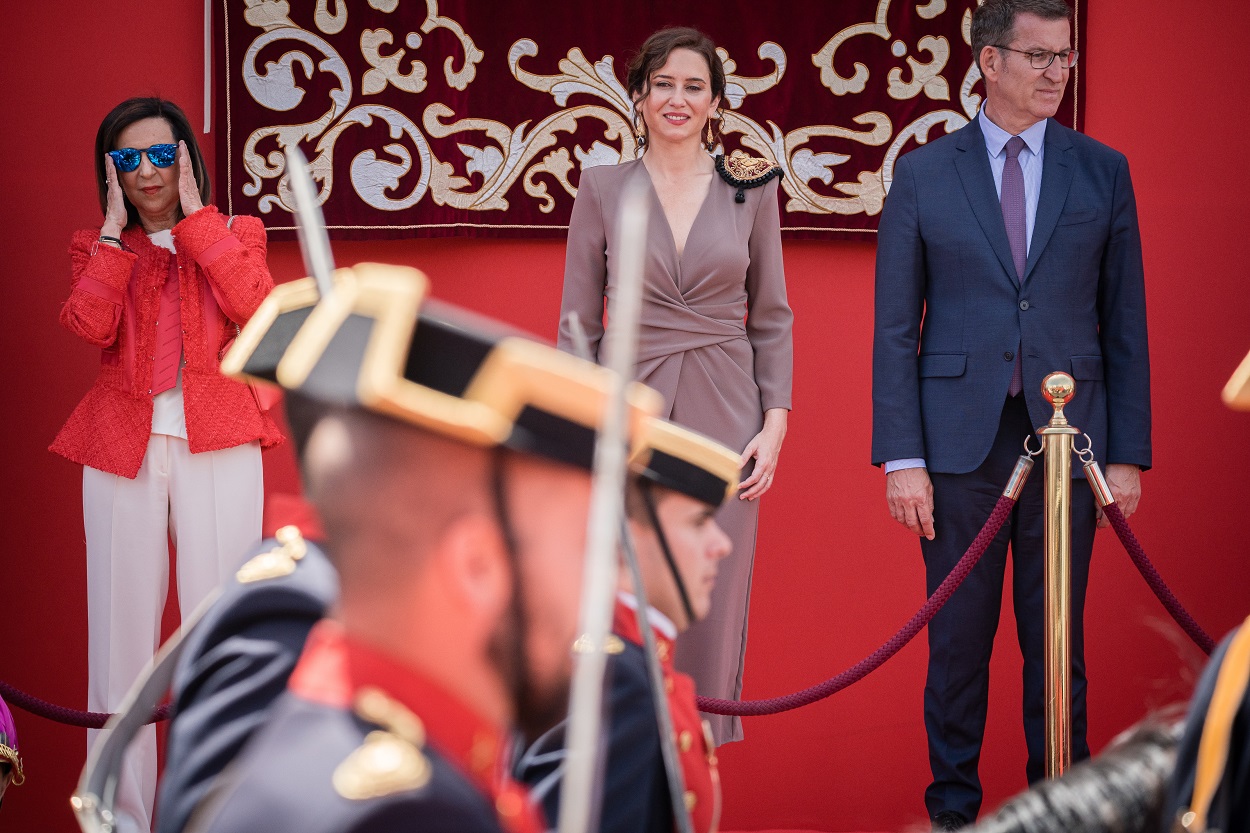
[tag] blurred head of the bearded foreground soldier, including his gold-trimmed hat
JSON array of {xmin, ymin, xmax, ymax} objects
[{"xmin": 236, "ymin": 264, "xmax": 659, "ymax": 734}]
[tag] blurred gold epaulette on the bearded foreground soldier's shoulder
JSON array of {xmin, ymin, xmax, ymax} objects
[{"xmin": 333, "ymin": 688, "xmax": 431, "ymax": 800}]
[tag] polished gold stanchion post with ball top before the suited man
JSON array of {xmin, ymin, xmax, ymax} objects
[{"xmin": 1038, "ymin": 373, "xmax": 1080, "ymax": 778}]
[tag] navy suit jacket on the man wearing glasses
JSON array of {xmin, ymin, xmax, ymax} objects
[{"xmin": 873, "ymin": 119, "xmax": 1150, "ymax": 474}]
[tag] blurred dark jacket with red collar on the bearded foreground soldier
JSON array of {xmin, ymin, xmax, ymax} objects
[{"xmin": 189, "ymin": 619, "xmax": 545, "ymax": 833}]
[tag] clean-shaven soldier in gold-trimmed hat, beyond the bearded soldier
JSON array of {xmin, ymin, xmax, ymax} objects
[{"xmin": 516, "ymin": 419, "xmax": 740, "ymax": 833}]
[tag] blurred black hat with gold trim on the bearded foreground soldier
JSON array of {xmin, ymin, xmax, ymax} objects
[{"xmin": 221, "ymin": 263, "xmax": 661, "ymax": 469}]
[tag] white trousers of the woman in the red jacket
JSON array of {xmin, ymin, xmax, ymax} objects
[{"xmin": 83, "ymin": 434, "xmax": 264, "ymax": 833}]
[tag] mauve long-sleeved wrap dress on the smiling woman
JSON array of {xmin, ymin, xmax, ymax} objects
[{"xmin": 559, "ymin": 160, "xmax": 794, "ymax": 743}]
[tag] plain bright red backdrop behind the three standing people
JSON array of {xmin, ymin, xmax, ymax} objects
[{"xmin": 0, "ymin": 0, "xmax": 1250, "ymax": 833}]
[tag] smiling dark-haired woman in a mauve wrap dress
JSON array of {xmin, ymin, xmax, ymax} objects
[{"xmin": 560, "ymin": 29, "xmax": 794, "ymax": 743}]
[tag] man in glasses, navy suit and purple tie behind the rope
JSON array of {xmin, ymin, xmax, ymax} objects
[{"xmin": 873, "ymin": 0, "xmax": 1150, "ymax": 829}]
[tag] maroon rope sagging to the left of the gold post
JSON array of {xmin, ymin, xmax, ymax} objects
[{"xmin": 695, "ymin": 495, "xmax": 1015, "ymax": 717}]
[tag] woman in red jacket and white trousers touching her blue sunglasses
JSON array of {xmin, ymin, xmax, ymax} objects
[{"xmin": 51, "ymin": 98, "xmax": 281, "ymax": 830}]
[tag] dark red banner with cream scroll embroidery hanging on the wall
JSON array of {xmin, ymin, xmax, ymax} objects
[{"xmin": 214, "ymin": 0, "xmax": 1088, "ymax": 239}]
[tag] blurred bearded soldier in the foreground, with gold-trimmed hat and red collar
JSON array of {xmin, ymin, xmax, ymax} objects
[{"xmin": 177, "ymin": 265, "xmax": 659, "ymax": 833}]
